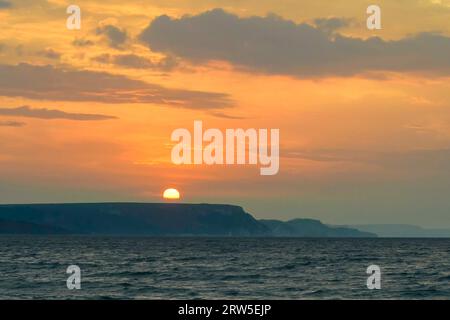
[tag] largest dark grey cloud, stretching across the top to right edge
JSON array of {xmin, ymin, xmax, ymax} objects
[{"xmin": 139, "ymin": 9, "xmax": 450, "ymax": 77}]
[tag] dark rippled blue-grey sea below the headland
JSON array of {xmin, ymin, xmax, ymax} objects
[{"xmin": 0, "ymin": 236, "xmax": 450, "ymax": 300}]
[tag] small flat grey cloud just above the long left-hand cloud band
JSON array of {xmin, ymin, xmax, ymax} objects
[{"xmin": 92, "ymin": 54, "xmax": 177, "ymax": 71}]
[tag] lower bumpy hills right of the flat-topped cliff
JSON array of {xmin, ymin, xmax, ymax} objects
[{"xmin": 259, "ymin": 219, "xmax": 376, "ymax": 238}]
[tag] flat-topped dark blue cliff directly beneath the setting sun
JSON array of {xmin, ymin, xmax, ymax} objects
[{"xmin": 0, "ymin": 203, "xmax": 268, "ymax": 236}]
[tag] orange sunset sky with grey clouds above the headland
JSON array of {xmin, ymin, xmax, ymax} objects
[{"xmin": 0, "ymin": 0, "xmax": 450, "ymax": 227}]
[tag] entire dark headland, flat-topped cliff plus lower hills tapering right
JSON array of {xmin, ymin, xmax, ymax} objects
[{"xmin": 0, "ymin": 203, "xmax": 376, "ymax": 237}]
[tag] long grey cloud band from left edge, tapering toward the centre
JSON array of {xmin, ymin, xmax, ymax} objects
[{"xmin": 0, "ymin": 63, "xmax": 232, "ymax": 109}]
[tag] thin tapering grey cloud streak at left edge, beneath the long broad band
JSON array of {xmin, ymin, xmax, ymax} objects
[{"xmin": 0, "ymin": 106, "xmax": 117, "ymax": 121}]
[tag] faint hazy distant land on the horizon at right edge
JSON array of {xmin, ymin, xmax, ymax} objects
[{"xmin": 349, "ymin": 224, "xmax": 450, "ymax": 238}]
